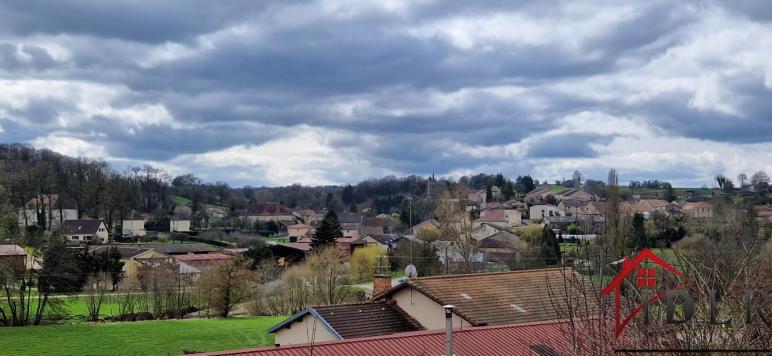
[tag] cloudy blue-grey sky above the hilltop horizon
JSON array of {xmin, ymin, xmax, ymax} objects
[{"xmin": 0, "ymin": 0, "xmax": 772, "ymax": 186}]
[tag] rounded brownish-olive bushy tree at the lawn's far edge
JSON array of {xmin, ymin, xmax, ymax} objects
[{"xmin": 198, "ymin": 257, "xmax": 256, "ymax": 318}]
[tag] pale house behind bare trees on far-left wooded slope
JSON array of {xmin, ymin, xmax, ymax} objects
[{"xmin": 17, "ymin": 194, "xmax": 78, "ymax": 230}]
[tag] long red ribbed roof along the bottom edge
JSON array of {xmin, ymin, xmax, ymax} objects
[{"xmin": 201, "ymin": 321, "xmax": 613, "ymax": 356}]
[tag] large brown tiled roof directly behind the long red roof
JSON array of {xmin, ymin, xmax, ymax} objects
[{"xmin": 376, "ymin": 268, "xmax": 596, "ymax": 326}]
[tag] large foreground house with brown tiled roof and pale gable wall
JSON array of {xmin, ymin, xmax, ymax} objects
[{"xmin": 374, "ymin": 268, "xmax": 597, "ymax": 330}]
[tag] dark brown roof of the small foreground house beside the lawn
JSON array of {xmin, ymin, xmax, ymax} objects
[{"xmin": 268, "ymin": 301, "xmax": 423, "ymax": 339}]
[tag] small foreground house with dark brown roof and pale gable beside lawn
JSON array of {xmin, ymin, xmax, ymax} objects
[{"xmin": 268, "ymin": 301, "xmax": 423, "ymax": 346}]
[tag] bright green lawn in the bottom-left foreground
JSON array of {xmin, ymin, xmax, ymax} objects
[{"xmin": 0, "ymin": 316, "xmax": 285, "ymax": 356}]
